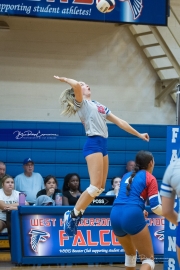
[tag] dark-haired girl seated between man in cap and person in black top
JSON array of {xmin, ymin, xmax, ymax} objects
[{"xmin": 36, "ymin": 175, "xmax": 61, "ymax": 200}]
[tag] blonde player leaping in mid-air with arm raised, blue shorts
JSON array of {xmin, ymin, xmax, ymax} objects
[{"xmin": 54, "ymin": 76, "xmax": 149, "ymax": 236}]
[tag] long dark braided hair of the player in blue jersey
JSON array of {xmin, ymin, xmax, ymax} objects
[{"xmin": 126, "ymin": 150, "xmax": 153, "ymax": 195}]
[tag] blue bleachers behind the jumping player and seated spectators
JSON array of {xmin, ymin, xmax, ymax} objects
[{"xmin": 0, "ymin": 121, "xmax": 167, "ymax": 191}]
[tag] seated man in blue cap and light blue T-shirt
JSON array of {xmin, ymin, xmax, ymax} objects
[{"xmin": 14, "ymin": 158, "xmax": 44, "ymax": 205}]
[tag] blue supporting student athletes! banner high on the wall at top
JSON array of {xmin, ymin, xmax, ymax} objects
[{"xmin": 0, "ymin": 0, "xmax": 169, "ymax": 26}]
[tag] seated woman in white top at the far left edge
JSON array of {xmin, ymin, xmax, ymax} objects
[{"xmin": 0, "ymin": 175, "xmax": 28, "ymax": 232}]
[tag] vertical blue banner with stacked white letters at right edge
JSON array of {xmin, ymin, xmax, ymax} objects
[{"xmin": 164, "ymin": 126, "xmax": 180, "ymax": 270}]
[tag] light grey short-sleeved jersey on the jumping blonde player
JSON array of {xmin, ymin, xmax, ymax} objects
[{"xmin": 74, "ymin": 99, "xmax": 111, "ymax": 138}]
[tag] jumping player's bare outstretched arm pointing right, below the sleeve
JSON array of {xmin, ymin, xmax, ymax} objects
[{"xmin": 106, "ymin": 113, "xmax": 149, "ymax": 142}]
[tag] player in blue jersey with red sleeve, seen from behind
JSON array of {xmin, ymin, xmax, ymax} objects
[{"xmin": 110, "ymin": 151, "xmax": 162, "ymax": 270}]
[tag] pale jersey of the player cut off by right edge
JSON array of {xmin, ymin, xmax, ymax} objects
[{"xmin": 160, "ymin": 158, "xmax": 180, "ymax": 222}]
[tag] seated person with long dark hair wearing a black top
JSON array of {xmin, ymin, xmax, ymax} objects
[{"xmin": 62, "ymin": 173, "xmax": 81, "ymax": 205}]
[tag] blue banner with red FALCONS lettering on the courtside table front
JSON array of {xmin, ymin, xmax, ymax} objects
[{"xmin": 21, "ymin": 214, "xmax": 164, "ymax": 257}]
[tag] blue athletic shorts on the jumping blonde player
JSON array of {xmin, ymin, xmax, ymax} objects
[{"xmin": 83, "ymin": 136, "xmax": 107, "ymax": 157}]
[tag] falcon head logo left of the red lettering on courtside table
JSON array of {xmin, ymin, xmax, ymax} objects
[{"xmin": 29, "ymin": 229, "xmax": 50, "ymax": 253}]
